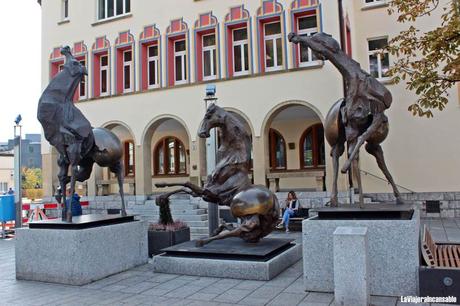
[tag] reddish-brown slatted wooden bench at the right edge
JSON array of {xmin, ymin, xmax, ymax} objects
[{"xmin": 422, "ymin": 226, "xmax": 460, "ymax": 268}]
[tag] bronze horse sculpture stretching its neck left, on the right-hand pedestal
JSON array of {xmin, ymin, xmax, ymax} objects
[{"xmin": 289, "ymin": 33, "xmax": 403, "ymax": 207}]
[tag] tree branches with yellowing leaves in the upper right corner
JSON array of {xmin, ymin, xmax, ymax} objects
[{"xmin": 387, "ymin": 0, "xmax": 460, "ymax": 118}]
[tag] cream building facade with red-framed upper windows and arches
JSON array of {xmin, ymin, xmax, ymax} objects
[{"xmin": 40, "ymin": 0, "xmax": 460, "ymax": 203}]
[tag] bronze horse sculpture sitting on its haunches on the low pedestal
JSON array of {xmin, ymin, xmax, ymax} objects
[{"xmin": 156, "ymin": 104, "xmax": 279, "ymax": 246}]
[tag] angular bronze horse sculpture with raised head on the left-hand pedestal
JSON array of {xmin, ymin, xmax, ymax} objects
[{"xmin": 37, "ymin": 46, "xmax": 126, "ymax": 222}]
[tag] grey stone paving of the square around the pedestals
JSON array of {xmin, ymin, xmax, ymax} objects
[{"xmin": 0, "ymin": 220, "xmax": 460, "ymax": 306}]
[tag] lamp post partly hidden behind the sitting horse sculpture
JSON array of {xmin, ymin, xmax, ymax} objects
[{"xmin": 204, "ymin": 85, "xmax": 219, "ymax": 234}]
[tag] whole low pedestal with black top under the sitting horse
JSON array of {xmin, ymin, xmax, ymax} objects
[{"xmin": 153, "ymin": 238, "xmax": 302, "ymax": 280}]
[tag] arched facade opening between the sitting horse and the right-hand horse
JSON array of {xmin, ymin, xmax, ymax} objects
[{"xmin": 264, "ymin": 102, "xmax": 326, "ymax": 191}]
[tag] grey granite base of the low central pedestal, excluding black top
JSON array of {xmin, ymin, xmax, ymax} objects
[{"xmin": 153, "ymin": 244, "xmax": 302, "ymax": 280}]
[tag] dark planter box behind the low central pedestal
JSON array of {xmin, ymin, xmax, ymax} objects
[{"xmin": 148, "ymin": 227, "xmax": 190, "ymax": 256}]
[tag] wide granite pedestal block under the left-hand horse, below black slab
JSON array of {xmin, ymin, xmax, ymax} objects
[{"xmin": 15, "ymin": 221, "xmax": 148, "ymax": 285}]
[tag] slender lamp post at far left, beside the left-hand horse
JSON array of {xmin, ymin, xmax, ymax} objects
[{"xmin": 14, "ymin": 115, "xmax": 22, "ymax": 228}]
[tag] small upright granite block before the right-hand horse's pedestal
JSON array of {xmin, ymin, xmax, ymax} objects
[{"xmin": 333, "ymin": 227, "xmax": 370, "ymax": 306}]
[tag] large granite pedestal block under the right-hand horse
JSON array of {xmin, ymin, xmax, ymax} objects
[{"xmin": 302, "ymin": 210, "xmax": 420, "ymax": 296}]
